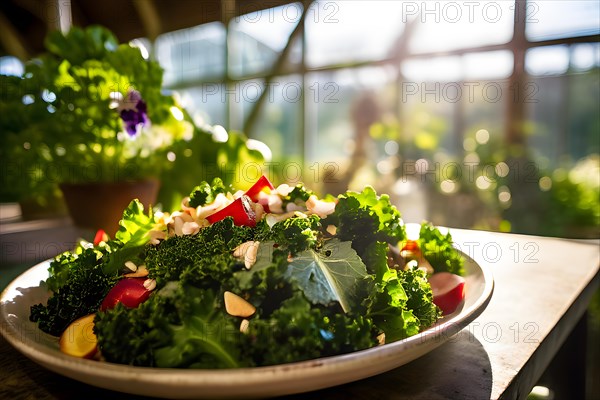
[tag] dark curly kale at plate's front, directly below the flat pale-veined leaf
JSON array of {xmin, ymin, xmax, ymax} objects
[{"xmin": 241, "ymin": 292, "xmax": 376, "ymax": 365}]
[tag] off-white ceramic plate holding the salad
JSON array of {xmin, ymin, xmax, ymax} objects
[{"xmin": 0, "ymin": 252, "xmax": 494, "ymax": 398}]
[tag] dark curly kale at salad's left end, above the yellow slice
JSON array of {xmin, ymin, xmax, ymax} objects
[{"xmin": 29, "ymin": 249, "xmax": 118, "ymax": 336}]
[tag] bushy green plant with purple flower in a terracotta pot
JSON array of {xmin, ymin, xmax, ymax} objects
[{"xmin": 0, "ymin": 26, "xmax": 261, "ymax": 231}]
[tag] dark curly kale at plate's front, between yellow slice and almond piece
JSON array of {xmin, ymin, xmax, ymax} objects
[{"xmin": 95, "ymin": 282, "xmax": 249, "ymax": 368}]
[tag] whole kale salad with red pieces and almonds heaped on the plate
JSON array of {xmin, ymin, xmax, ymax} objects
[{"xmin": 30, "ymin": 176, "xmax": 465, "ymax": 369}]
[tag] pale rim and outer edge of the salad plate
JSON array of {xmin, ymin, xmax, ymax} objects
[{"xmin": 0, "ymin": 250, "xmax": 495, "ymax": 398}]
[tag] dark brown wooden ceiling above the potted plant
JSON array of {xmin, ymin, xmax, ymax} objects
[{"xmin": 0, "ymin": 0, "xmax": 300, "ymax": 59}]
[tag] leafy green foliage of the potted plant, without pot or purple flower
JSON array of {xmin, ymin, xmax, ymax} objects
[{"xmin": 0, "ymin": 26, "xmax": 262, "ymax": 210}]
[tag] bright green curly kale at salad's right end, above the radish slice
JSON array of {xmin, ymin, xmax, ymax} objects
[{"xmin": 418, "ymin": 223, "xmax": 465, "ymax": 275}]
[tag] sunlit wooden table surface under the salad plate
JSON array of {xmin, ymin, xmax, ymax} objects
[{"xmin": 0, "ymin": 230, "xmax": 600, "ymax": 400}]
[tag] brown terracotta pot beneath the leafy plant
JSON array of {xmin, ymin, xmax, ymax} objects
[{"xmin": 60, "ymin": 180, "xmax": 160, "ymax": 237}]
